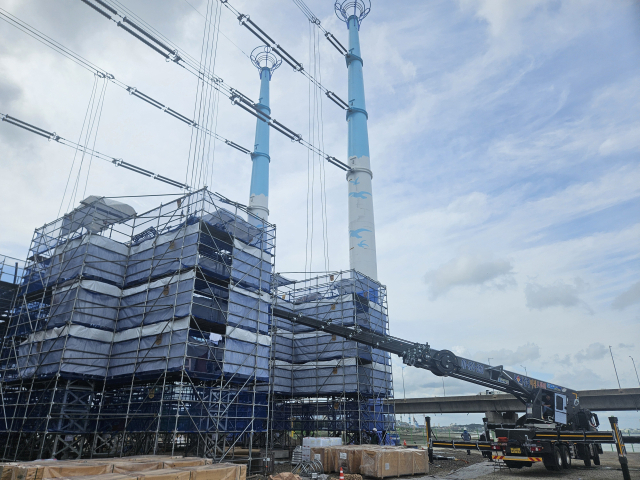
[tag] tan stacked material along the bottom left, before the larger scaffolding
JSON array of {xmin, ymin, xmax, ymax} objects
[{"xmin": 0, "ymin": 456, "xmax": 247, "ymax": 480}]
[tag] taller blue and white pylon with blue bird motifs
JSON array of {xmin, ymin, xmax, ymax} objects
[{"xmin": 335, "ymin": 0, "xmax": 378, "ymax": 280}]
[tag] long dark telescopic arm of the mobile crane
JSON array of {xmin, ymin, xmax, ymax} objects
[{"xmin": 273, "ymin": 307, "xmax": 577, "ymax": 404}]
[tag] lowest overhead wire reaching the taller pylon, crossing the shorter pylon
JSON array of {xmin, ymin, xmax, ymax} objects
[{"xmin": 76, "ymin": 0, "xmax": 349, "ymax": 171}]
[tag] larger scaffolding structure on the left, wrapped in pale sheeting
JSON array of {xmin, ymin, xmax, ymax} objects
[{"xmin": 0, "ymin": 189, "xmax": 275, "ymax": 467}]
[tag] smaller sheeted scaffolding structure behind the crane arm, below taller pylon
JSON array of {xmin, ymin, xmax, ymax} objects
[{"xmin": 271, "ymin": 270, "xmax": 395, "ymax": 447}]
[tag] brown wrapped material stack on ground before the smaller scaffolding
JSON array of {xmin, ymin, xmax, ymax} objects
[{"xmin": 311, "ymin": 445, "xmax": 429, "ymax": 478}]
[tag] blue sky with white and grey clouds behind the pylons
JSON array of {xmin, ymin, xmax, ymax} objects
[{"xmin": 0, "ymin": 0, "xmax": 640, "ymax": 428}]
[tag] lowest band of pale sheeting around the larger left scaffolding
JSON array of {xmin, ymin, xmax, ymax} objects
[{"xmin": 18, "ymin": 318, "xmax": 271, "ymax": 382}]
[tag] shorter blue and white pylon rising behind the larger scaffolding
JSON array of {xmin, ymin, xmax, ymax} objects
[{"xmin": 248, "ymin": 47, "xmax": 282, "ymax": 226}]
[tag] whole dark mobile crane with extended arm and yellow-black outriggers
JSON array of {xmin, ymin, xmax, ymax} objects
[{"xmin": 273, "ymin": 306, "xmax": 637, "ymax": 480}]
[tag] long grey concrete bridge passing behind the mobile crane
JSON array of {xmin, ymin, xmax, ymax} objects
[{"xmin": 392, "ymin": 388, "xmax": 640, "ymax": 414}]
